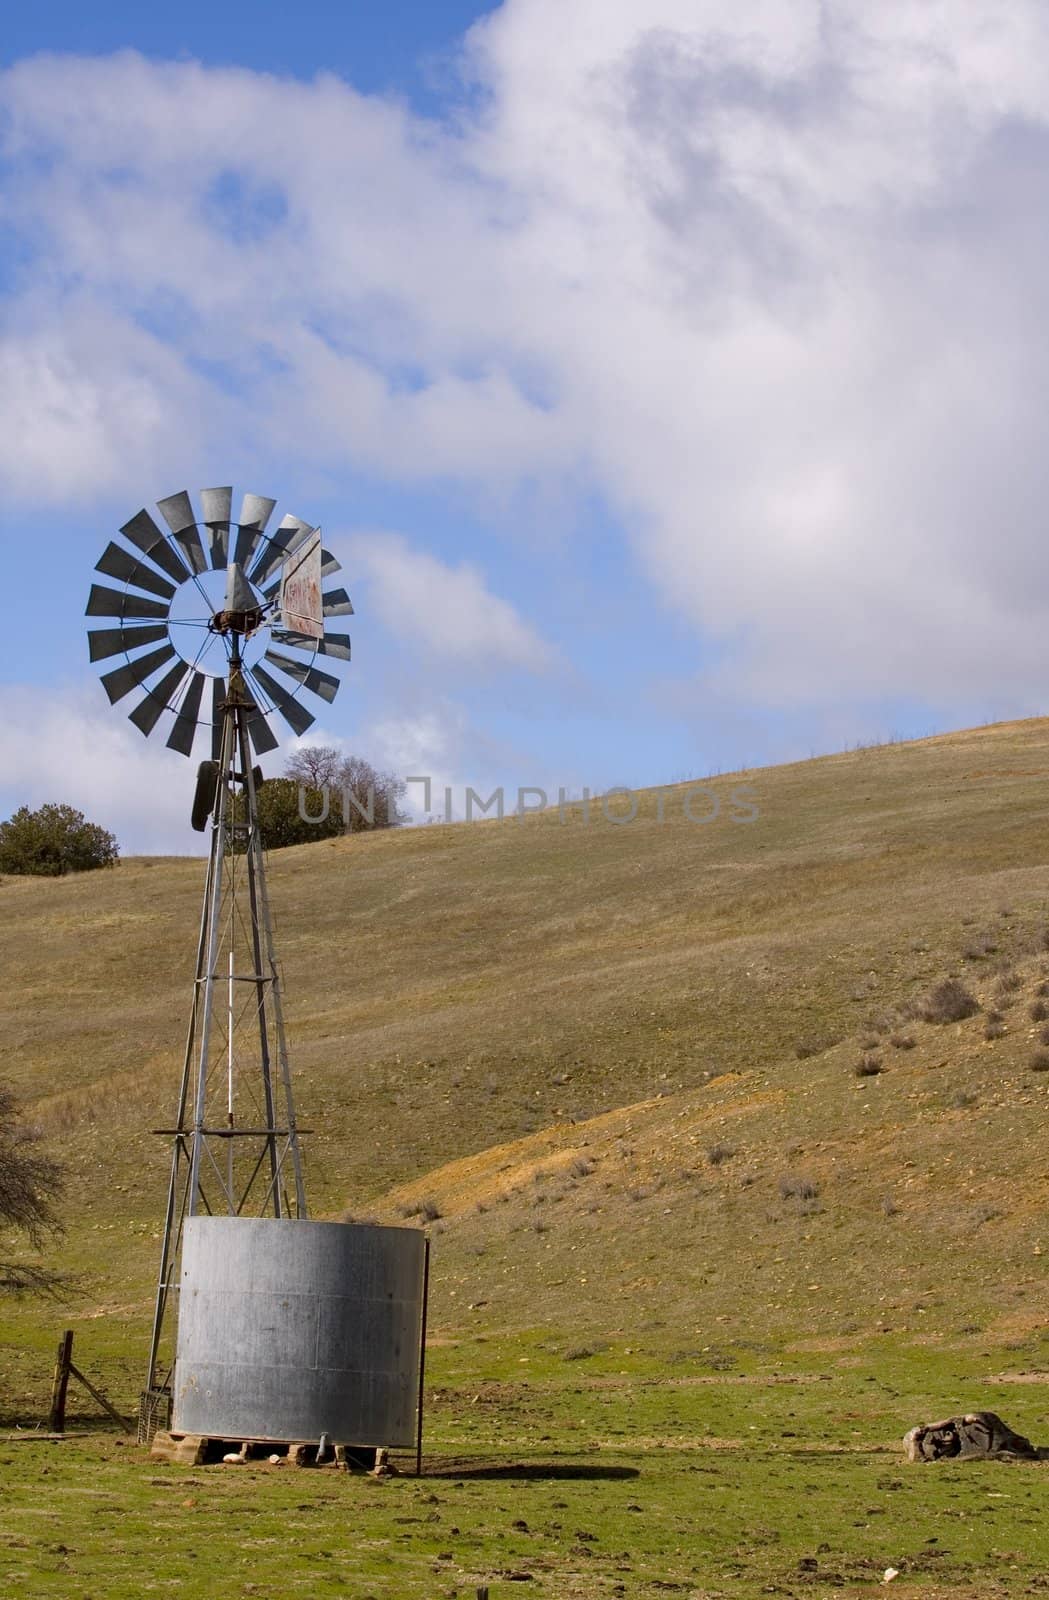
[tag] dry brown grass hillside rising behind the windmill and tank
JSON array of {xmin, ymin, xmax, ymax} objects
[{"xmin": 0, "ymin": 720, "xmax": 1049, "ymax": 1358}]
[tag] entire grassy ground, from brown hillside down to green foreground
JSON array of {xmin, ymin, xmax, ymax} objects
[{"xmin": 0, "ymin": 722, "xmax": 1049, "ymax": 1600}]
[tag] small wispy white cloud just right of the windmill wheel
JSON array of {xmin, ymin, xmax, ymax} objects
[{"xmin": 339, "ymin": 533, "xmax": 553, "ymax": 672}]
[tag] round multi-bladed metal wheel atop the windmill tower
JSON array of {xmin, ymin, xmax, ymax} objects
[{"xmin": 86, "ymin": 486, "xmax": 353, "ymax": 760}]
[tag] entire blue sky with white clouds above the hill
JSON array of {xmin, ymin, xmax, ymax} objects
[{"xmin": 0, "ymin": 0, "xmax": 1049, "ymax": 850}]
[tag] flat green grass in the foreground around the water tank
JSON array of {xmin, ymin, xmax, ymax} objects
[{"xmin": 0, "ymin": 1338, "xmax": 1049, "ymax": 1600}]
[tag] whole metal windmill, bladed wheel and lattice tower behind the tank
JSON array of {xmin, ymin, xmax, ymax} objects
[{"xmin": 86, "ymin": 488, "xmax": 352, "ymax": 1432}]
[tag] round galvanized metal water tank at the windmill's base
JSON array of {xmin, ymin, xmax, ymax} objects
[{"xmin": 171, "ymin": 1216, "xmax": 425, "ymax": 1448}]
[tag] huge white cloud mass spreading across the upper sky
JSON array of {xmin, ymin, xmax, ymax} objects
[{"xmin": 0, "ymin": 0, "xmax": 1049, "ymax": 723}]
